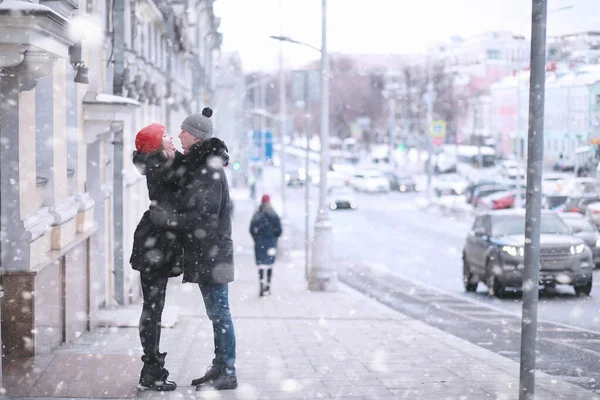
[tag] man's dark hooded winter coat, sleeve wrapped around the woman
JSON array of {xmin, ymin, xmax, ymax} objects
[{"xmin": 151, "ymin": 138, "xmax": 234, "ymax": 284}]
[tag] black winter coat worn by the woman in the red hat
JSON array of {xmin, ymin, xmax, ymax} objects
[{"xmin": 129, "ymin": 151, "xmax": 183, "ymax": 276}]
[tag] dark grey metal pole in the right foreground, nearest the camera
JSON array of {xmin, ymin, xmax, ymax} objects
[{"xmin": 519, "ymin": 0, "xmax": 548, "ymax": 400}]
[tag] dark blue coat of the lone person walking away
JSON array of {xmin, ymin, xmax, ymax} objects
[{"xmin": 250, "ymin": 204, "xmax": 282, "ymax": 265}]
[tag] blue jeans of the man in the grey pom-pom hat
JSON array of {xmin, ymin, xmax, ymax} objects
[{"xmin": 199, "ymin": 284, "xmax": 235, "ymax": 375}]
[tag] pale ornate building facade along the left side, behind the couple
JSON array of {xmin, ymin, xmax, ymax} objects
[{"xmin": 0, "ymin": 0, "xmax": 222, "ymax": 364}]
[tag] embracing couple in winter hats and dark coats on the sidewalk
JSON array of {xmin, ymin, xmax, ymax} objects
[{"xmin": 130, "ymin": 108, "xmax": 237, "ymax": 391}]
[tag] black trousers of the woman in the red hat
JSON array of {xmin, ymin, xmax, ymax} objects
[{"xmin": 139, "ymin": 273, "xmax": 169, "ymax": 358}]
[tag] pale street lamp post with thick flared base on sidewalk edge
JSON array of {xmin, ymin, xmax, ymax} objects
[{"xmin": 308, "ymin": 0, "xmax": 337, "ymax": 291}]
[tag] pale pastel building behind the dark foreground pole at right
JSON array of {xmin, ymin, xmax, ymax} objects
[{"xmin": 490, "ymin": 65, "xmax": 600, "ymax": 165}]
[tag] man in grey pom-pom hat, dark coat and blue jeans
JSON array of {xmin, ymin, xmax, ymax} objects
[{"xmin": 151, "ymin": 108, "xmax": 238, "ymax": 390}]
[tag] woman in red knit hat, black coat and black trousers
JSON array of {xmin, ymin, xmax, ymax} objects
[{"xmin": 129, "ymin": 123, "xmax": 183, "ymax": 391}]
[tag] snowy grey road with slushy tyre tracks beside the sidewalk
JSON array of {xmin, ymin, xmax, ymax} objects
[{"xmin": 265, "ymin": 162, "xmax": 600, "ymax": 392}]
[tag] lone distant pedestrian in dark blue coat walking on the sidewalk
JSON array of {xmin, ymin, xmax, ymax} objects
[{"xmin": 250, "ymin": 194, "xmax": 282, "ymax": 297}]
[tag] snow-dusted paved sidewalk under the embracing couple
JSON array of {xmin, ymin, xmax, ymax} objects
[{"xmin": 4, "ymin": 193, "xmax": 600, "ymax": 400}]
